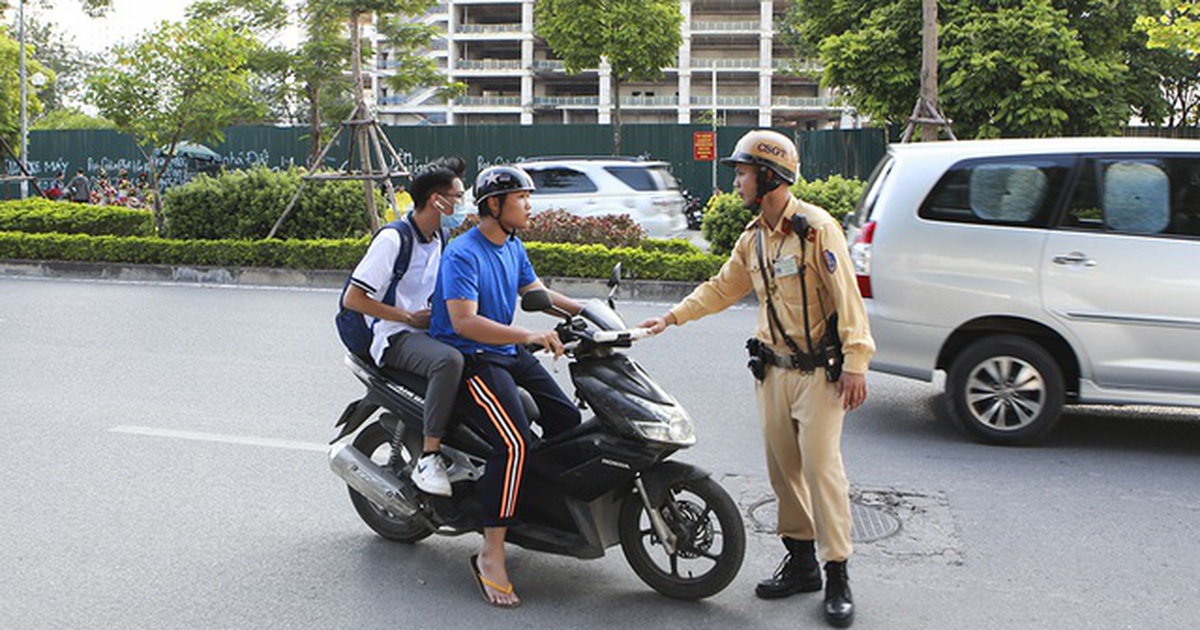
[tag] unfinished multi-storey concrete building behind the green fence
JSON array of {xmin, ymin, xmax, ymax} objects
[{"xmin": 372, "ymin": 0, "xmax": 842, "ymax": 128}]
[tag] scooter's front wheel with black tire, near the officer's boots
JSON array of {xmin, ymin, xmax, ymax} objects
[{"xmin": 618, "ymin": 478, "xmax": 746, "ymax": 600}]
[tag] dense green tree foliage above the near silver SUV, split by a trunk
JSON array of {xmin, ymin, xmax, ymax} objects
[{"xmin": 786, "ymin": 0, "xmax": 1177, "ymax": 137}]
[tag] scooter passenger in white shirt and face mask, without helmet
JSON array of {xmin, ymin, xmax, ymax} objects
[{"xmin": 342, "ymin": 157, "xmax": 466, "ymax": 497}]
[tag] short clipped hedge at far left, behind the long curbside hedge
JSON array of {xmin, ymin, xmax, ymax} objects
[{"xmin": 0, "ymin": 198, "xmax": 154, "ymax": 236}]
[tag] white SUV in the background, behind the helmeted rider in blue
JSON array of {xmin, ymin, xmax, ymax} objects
[{"xmin": 516, "ymin": 157, "xmax": 688, "ymax": 238}]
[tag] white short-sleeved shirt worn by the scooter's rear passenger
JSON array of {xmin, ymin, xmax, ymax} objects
[{"xmin": 350, "ymin": 216, "xmax": 442, "ymax": 366}]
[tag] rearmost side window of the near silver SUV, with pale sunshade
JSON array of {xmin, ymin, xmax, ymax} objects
[{"xmin": 918, "ymin": 156, "xmax": 1070, "ymax": 227}]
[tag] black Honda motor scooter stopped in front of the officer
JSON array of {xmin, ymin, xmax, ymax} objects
[{"xmin": 330, "ymin": 265, "xmax": 745, "ymax": 600}]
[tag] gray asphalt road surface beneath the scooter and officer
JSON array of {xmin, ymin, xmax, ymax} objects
[{"xmin": 0, "ymin": 277, "xmax": 1200, "ymax": 630}]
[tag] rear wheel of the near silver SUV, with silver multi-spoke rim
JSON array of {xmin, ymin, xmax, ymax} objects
[{"xmin": 946, "ymin": 335, "xmax": 1063, "ymax": 444}]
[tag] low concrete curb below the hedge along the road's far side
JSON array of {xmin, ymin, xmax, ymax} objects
[{"xmin": 0, "ymin": 259, "xmax": 715, "ymax": 302}]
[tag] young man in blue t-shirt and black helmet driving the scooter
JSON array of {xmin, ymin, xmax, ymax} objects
[{"xmin": 430, "ymin": 167, "xmax": 581, "ymax": 607}]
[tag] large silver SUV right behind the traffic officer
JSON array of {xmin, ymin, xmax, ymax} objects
[{"xmin": 846, "ymin": 138, "xmax": 1200, "ymax": 444}]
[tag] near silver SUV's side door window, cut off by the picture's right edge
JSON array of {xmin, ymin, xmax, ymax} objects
[{"xmin": 1062, "ymin": 157, "xmax": 1200, "ymax": 236}]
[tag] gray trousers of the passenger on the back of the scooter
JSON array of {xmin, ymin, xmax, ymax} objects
[{"xmin": 383, "ymin": 332, "xmax": 462, "ymax": 439}]
